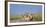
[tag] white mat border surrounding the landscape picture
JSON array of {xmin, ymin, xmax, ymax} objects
[{"xmin": 8, "ymin": 2, "xmax": 44, "ymax": 25}]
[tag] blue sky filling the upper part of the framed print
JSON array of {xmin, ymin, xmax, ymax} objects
[{"xmin": 10, "ymin": 4, "xmax": 42, "ymax": 15}]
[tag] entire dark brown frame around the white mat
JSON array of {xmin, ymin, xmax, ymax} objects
[{"xmin": 5, "ymin": 1, "xmax": 45, "ymax": 26}]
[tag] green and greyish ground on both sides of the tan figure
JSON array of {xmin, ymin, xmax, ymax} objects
[{"xmin": 10, "ymin": 14, "xmax": 42, "ymax": 23}]
